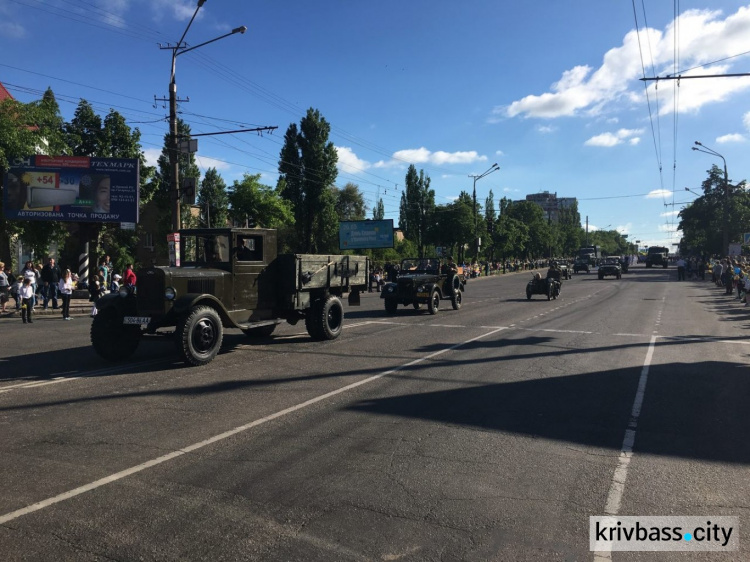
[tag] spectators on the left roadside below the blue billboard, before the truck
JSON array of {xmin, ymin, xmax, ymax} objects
[{"xmin": 0, "ymin": 256, "xmax": 136, "ymax": 324}]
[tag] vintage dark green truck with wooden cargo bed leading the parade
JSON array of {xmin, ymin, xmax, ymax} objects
[{"xmin": 91, "ymin": 228, "xmax": 369, "ymax": 366}]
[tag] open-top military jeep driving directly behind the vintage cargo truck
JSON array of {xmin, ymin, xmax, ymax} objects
[{"xmin": 380, "ymin": 258, "xmax": 466, "ymax": 314}]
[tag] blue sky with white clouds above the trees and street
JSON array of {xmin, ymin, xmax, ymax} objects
[{"xmin": 0, "ymin": 0, "xmax": 750, "ymax": 245}]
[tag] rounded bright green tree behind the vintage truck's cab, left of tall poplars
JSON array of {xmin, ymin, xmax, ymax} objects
[{"xmin": 228, "ymin": 174, "xmax": 294, "ymax": 228}]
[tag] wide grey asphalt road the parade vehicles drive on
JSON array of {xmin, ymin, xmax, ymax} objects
[{"xmin": 0, "ymin": 266, "xmax": 750, "ymax": 561}]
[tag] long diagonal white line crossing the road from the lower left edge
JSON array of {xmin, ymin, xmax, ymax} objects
[{"xmin": 0, "ymin": 328, "xmax": 505, "ymax": 525}]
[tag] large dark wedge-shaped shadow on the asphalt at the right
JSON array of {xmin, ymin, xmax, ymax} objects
[{"xmin": 348, "ymin": 354, "xmax": 750, "ymax": 464}]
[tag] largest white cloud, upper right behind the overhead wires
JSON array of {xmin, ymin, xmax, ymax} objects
[{"xmin": 496, "ymin": 6, "xmax": 750, "ymax": 122}]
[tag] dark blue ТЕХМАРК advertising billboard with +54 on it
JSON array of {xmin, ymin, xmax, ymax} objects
[{"xmin": 3, "ymin": 156, "xmax": 140, "ymax": 223}]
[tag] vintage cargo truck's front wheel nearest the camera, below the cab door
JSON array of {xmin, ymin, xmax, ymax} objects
[{"xmin": 175, "ymin": 306, "xmax": 224, "ymax": 367}]
